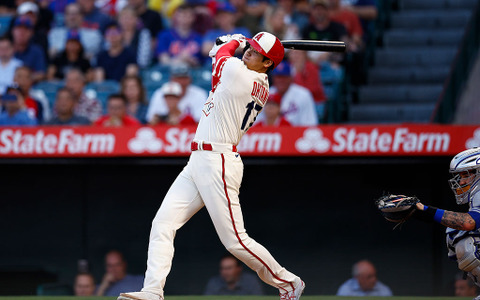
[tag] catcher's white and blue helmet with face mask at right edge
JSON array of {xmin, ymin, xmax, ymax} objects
[{"xmin": 448, "ymin": 147, "xmax": 480, "ymax": 204}]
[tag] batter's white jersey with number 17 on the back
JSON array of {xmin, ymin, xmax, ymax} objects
[{"xmin": 195, "ymin": 50, "xmax": 269, "ymax": 145}]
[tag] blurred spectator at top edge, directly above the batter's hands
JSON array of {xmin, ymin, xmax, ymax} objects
[{"xmin": 230, "ymin": 0, "xmax": 269, "ymax": 32}]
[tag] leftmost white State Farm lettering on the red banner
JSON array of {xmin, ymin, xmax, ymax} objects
[{"xmin": 0, "ymin": 129, "xmax": 115, "ymax": 154}]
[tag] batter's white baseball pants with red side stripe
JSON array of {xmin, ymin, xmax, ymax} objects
[{"xmin": 142, "ymin": 146, "xmax": 298, "ymax": 298}]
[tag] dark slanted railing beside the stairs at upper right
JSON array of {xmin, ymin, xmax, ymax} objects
[{"xmin": 430, "ymin": 2, "xmax": 480, "ymax": 123}]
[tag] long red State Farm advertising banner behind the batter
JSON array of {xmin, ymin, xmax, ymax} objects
[{"xmin": 0, "ymin": 125, "xmax": 480, "ymax": 158}]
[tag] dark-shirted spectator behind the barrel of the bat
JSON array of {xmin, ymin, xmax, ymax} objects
[{"xmin": 302, "ymin": 0, "xmax": 348, "ymax": 67}]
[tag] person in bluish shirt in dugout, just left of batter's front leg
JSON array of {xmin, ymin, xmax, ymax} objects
[{"xmin": 97, "ymin": 250, "xmax": 143, "ymax": 296}]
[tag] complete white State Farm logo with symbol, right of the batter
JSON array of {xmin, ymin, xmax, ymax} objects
[{"xmin": 295, "ymin": 127, "xmax": 450, "ymax": 153}]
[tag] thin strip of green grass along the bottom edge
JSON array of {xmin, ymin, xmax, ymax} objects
[{"xmin": 0, "ymin": 296, "xmax": 472, "ymax": 300}]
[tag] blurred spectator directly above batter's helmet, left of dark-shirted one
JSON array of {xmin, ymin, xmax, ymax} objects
[{"xmin": 265, "ymin": 5, "xmax": 300, "ymax": 40}]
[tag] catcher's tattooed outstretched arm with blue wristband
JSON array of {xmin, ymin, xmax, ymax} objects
[{"xmin": 416, "ymin": 202, "xmax": 480, "ymax": 231}]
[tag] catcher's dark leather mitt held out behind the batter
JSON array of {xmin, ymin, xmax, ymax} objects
[{"xmin": 375, "ymin": 195, "xmax": 420, "ymax": 223}]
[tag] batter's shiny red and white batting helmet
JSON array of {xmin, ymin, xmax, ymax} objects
[{"xmin": 247, "ymin": 32, "xmax": 285, "ymax": 67}]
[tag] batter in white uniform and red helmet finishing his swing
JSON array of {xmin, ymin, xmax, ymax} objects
[{"xmin": 118, "ymin": 32, "xmax": 305, "ymax": 300}]
